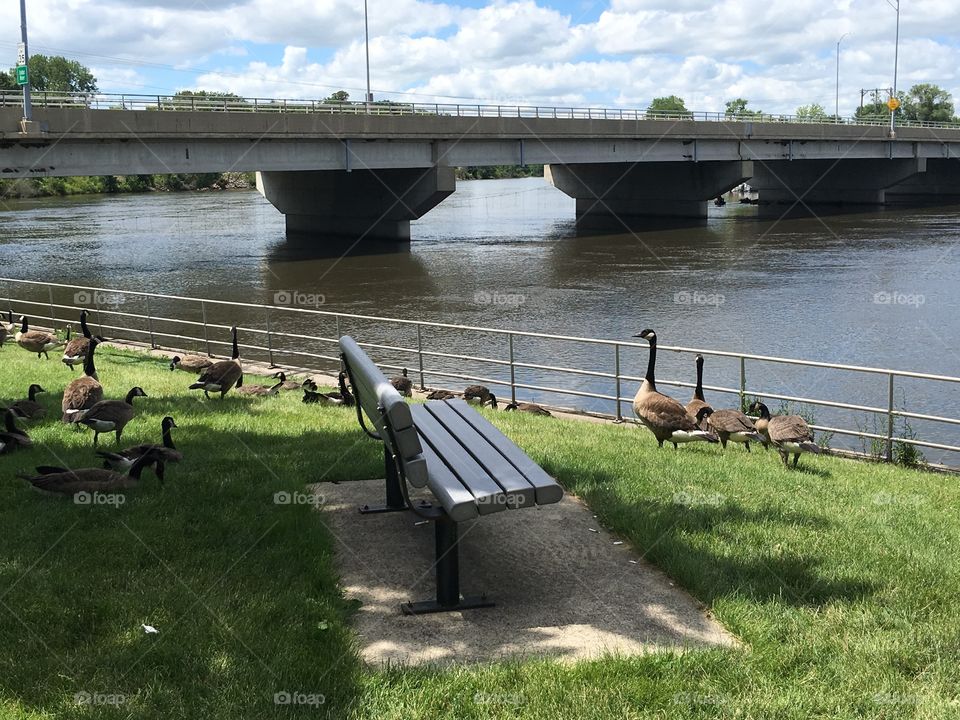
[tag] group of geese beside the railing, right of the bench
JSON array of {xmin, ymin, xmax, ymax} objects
[{"xmin": 633, "ymin": 329, "xmax": 820, "ymax": 467}]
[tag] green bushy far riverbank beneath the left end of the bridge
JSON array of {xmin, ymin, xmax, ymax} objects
[{"xmin": 0, "ymin": 172, "xmax": 255, "ymax": 199}]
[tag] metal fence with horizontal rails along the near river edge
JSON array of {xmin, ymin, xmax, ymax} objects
[{"xmin": 0, "ymin": 278, "xmax": 960, "ymax": 469}]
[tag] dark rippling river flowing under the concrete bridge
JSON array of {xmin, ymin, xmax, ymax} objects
[{"xmin": 0, "ymin": 178, "xmax": 960, "ymax": 464}]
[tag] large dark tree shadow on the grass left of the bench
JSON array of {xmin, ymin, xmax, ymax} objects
[{"xmin": 0, "ymin": 402, "xmax": 382, "ymax": 718}]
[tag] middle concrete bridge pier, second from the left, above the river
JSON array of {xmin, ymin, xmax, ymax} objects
[{"xmin": 544, "ymin": 160, "xmax": 753, "ymax": 229}]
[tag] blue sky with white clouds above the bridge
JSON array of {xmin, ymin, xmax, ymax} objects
[{"xmin": 0, "ymin": 0, "xmax": 960, "ymax": 115}]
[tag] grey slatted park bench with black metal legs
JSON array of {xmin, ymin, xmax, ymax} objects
[{"xmin": 340, "ymin": 336, "xmax": 563, "ymax": 615}]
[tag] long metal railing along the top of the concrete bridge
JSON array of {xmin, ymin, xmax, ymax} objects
[{"xmin": 0, "ymin": 91, "xmax": 960, "ymax": 129}]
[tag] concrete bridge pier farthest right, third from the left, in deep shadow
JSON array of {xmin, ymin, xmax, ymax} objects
[{"xmin": 750, "ymin": 158, "xmax": 926, "ymax": 215}]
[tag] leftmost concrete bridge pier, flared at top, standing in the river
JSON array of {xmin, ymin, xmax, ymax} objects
[{"xmin": 257, "ymin": 167, "xmax": 456, "ymax": 243}]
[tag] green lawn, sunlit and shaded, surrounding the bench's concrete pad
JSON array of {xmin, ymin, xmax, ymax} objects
[{"xmin": 0, "ymin": 345, "xmax": 960, "ymax": 719}]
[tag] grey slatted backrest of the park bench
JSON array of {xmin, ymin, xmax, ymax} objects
[{"xmin": 340, "ymin": 335, "xmax": 427, "ymax": 487}]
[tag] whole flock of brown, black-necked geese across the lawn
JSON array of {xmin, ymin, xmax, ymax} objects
[{"xmin": 0, "ymin": 310, "xmax": 820, "ymax": 495}]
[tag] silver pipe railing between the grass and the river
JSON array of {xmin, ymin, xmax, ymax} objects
[{"xmin": 0, "ymin": 278, "xmax": 960, "ymax": 469}]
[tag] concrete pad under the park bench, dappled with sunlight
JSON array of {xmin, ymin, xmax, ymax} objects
[{"xmin": 314, "ymin": 480, "xmax": 737, "ymax": 665}]
